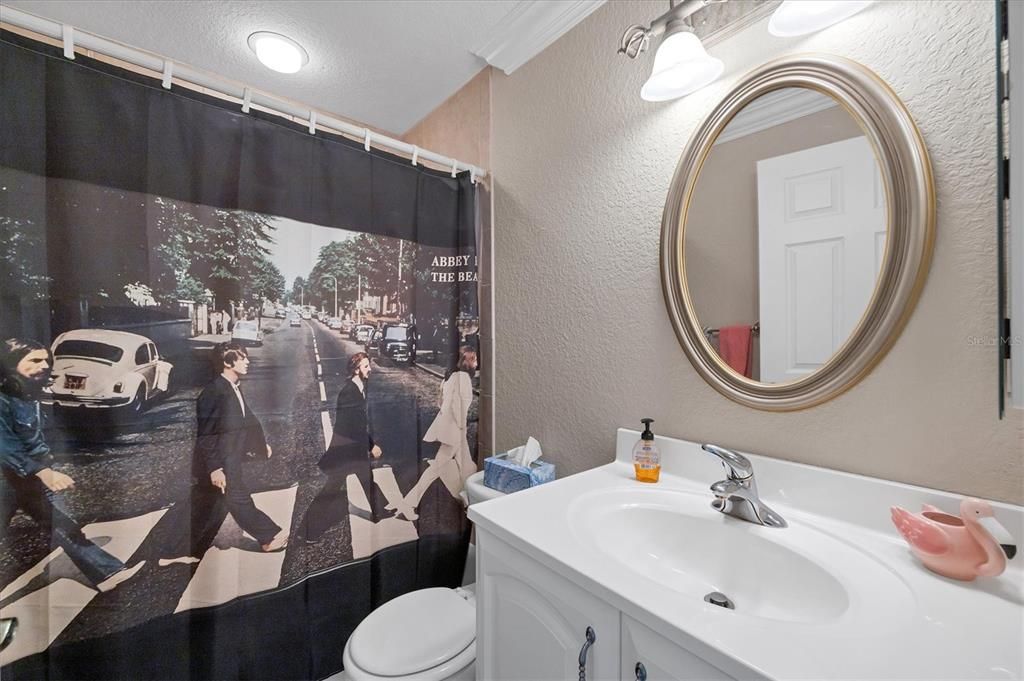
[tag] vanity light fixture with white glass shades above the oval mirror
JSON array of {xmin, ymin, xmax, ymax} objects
[{"xmin": 618, "ymin": 0, "xmax": 873, "ymax": 101}]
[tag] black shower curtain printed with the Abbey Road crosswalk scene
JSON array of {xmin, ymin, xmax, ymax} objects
[{"xmin": 0, "ymin": 33, "xmax": 479, "ymax": 679}]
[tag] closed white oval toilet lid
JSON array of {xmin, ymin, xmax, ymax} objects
[{"xmin": 349, "ymin": 588, "xmax": 476, "ymax": 676}]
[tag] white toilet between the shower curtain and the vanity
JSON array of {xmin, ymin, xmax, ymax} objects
[{"xmin": 344, "ymin": 471, "xmax": 504, "ymax": 681}]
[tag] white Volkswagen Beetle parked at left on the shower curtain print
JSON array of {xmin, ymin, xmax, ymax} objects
[{"xmin": 50, "ymin": 329, "xmax": 173, "ymax": 414}]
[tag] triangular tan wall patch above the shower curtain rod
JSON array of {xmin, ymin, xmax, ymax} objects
[{"xmin": 401, "ymin": 67, "xmax": 493, "ymax": 168}]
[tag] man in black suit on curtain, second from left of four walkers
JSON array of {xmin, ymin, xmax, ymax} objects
[{"xmin": 160, "ymin": 343, "xmax": 288, "ymax": 565}]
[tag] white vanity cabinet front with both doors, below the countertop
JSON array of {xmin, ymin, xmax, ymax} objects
[{"xmin": 476, "ymin": 526, "xmax": 733, "ymax": 681}]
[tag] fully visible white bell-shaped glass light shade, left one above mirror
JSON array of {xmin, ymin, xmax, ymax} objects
[{"xmin": 640, "ymin": 31, "xmax": 725, "ymax": 101}]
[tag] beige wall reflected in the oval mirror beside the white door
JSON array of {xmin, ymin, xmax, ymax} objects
[{"xmin": 686, "ymin": 107, "xmax": 863, "ymax": 379}]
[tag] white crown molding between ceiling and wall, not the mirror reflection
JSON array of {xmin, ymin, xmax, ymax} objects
[{"xmin": 473, "ymin": 0, "xmax": 605, "ymax": 75}]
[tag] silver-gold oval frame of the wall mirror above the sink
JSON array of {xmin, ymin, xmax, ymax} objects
[{"xmin": 660, "ymin": 54, "xmax": 935, "ymax": 412}]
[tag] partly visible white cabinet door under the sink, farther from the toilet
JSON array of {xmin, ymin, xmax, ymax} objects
[{"xmin": 622, "ymin": 614, "xmax": 732, "ymax": 681}]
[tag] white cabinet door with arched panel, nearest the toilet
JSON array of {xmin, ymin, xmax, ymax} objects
[{"xmin": 476, "ymin": 528, "xmax": 620, "ymax": 681}]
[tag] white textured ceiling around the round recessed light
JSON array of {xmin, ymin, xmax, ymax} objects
[{"xmin": 4, "ymin": 0, "xmax": 517, "ymax": 134}]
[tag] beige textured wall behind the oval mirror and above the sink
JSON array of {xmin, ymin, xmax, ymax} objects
[{"xmin": 492, "ymin": 0, "xmax": 1024, "ymax": 503}]
